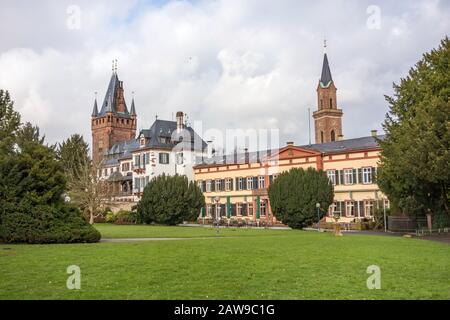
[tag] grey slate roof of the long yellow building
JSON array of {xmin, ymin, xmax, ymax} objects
[{"xmin": 196, "ymin": 135, "xmax": 384, "ymax": 167}]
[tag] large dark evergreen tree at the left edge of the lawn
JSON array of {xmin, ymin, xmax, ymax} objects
[{"xmin": 0, "ymin": 91, "xmax": 100, "ymax": 243}]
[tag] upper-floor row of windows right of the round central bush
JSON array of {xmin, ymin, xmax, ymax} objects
[{"xmin": 327, "ymin": 167, "xmax": 377, "ymax": 185}]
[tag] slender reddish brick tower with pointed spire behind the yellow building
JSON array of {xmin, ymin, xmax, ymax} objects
[{"xmin": 313, "ymin": 44, "xmax": 343, "ymax": 143}]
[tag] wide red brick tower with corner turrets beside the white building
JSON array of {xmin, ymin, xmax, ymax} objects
[{"xmin": 91, "ymin": 63, "xmax": 137, "ymax": 162}]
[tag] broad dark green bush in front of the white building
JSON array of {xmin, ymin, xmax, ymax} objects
[{"xmin": 137, "ymin": 174, "xmax": 205, "ymax": 225}]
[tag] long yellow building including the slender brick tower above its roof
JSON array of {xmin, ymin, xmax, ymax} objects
[{"xmin": 194, "ymin": 50, "xmax": 389, "ymax": 225}]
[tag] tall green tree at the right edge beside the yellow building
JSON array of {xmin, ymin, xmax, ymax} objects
[{"xmin": 377, "ymin": 38, "xmax": 450, "ymax": 222}]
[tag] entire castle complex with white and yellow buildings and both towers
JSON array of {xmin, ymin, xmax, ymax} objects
[{"xmin": 91, "ymin": 53, "xmax": 389, "ymax": 224}]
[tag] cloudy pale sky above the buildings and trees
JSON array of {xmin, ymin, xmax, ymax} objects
[{"xmin": 0, "ymin": 0, "xmax": 450, "ymax": 150}]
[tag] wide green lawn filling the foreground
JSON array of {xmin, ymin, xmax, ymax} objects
[{"xmin": 0, "ymin": 225, "xmax": 450, "ymax": 299}]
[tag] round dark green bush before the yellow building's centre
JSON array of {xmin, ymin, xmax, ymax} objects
[{"xmin": 268, "ymin": 168, "xmax": 334, "ymax": 228}]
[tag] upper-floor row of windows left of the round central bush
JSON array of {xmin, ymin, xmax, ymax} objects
[{"xmin": 197, "ymin": 175, "xmax": 276, "ymax": 192}]
